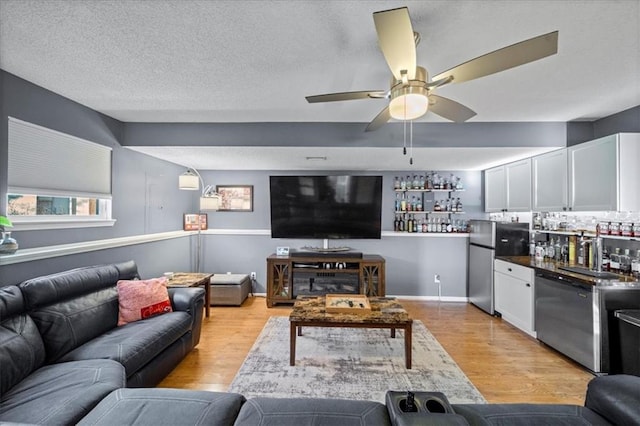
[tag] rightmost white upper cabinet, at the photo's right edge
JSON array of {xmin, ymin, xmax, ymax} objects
[{"xmin": 567, "ymin": 133, "xmax": 640, "ymax": 211}]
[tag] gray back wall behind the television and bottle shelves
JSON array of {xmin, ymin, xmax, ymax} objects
[{"xmin": 193, "ymin": 171, "xmax": 486, "ymax": 297}]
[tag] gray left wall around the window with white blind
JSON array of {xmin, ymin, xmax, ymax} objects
[{"xmin": 0, "ymin": 70, "xmax": 192, "ymax": 286}]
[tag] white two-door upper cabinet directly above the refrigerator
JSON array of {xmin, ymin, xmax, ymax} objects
[{"xmin": 484, "ymin": 158, "xmax": 531, "ymax": 212}]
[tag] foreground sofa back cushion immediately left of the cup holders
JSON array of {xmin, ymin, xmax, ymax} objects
[{"xmin": 236, "ymin": 398, "xmax": 391, "ymax": 426}]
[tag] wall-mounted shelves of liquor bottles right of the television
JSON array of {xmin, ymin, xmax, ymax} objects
[{"xmin": 393, "ymin": 172, "xmax": 467, "ymax": 233}]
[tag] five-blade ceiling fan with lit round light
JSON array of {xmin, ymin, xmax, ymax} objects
[{"xmin": 306, "ymin": 7, "xmax": 558, "ymax": 132}]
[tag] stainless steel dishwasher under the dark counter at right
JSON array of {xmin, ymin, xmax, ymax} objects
[{"xmin": 535, "ymin": 270, "xmax": 640, "ymax": 373}]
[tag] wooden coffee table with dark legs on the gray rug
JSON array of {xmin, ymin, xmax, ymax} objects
[{"xmin": 289, "ymin": 296, "xmax": 413, "ymax": 369}]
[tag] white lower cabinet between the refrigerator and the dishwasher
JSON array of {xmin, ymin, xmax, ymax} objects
[{"xmin": 493, "ymin": 259, "xmax": 536, "ymax": 337}]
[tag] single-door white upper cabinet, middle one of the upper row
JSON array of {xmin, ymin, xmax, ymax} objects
[{"xmin": 531, "ymin": 149, "xmax": 569, "ymax": 212}]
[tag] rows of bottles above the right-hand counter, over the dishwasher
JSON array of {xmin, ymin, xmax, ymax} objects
[{"xmin": 529, "ymin": 213, "xmax": 640, "ymax": 280}]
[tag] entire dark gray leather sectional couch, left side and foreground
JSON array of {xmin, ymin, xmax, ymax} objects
[{"xmin": 0, "ymin": 262, "xmax": 640, "ymax": 426}]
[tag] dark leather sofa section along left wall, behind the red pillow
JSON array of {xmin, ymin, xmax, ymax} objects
[{"xmin": 0, "ymin": 261, "xmax": 204, "ymax": 424}]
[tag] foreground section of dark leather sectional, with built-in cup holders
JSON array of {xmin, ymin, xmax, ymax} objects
[{"xmin": 80, "ymin": 375, "xmax": 640, "ymax": 426}]
